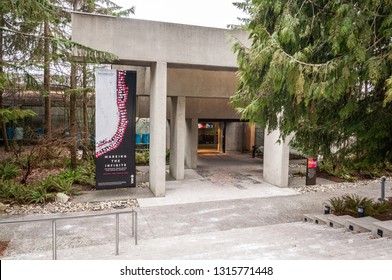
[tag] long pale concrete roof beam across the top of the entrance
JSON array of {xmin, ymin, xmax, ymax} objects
[{"xmin": 72, "ymin": 13, "xmax": 248, "ymax": 69}]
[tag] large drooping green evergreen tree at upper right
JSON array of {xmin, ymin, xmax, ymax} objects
[{"xmin": 231, "ymin": 0, "xmax": 392, "ymax": 174}]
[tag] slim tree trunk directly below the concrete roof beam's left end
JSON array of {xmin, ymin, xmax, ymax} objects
[{"xmin": 69, "ymin": 63, "xmax": 78, "ymax": 169}]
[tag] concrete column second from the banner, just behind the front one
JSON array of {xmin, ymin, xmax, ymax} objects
[{"xmin": 170, "ymin": 97, "xmax": 186, "ymax": 180}]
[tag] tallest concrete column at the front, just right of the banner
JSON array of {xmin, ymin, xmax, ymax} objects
[{"xmin": 150, "ymin": 62, "xmax": 167, "ymax": 196}]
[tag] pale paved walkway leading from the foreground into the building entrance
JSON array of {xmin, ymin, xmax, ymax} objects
[{"xmin": 0, "ymin": 154, "xmax": 392, "ymax": 259}]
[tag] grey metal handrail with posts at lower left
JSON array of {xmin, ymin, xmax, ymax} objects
[{"xmin": 0, "ymin": 209, "xmax": 137, "ymax": 260}]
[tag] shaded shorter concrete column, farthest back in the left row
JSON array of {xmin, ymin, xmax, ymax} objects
[{"xmin": 185, "ymin": 119, "xmax": 198, "ymax": 169}]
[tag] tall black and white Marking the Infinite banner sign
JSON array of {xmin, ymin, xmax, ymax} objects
[{"xmin": 95, "ymin": 69, "xmax": 136, "ymax": 189}]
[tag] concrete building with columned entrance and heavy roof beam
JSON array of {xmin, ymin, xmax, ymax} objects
[{"xmin": 72, "ymin": 13, "xmax": 289, "ymax": 196}]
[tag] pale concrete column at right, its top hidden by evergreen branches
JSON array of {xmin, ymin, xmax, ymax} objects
[{"xmin": 263, "ymin": 129, "xmax": 290, "ymax": 188}]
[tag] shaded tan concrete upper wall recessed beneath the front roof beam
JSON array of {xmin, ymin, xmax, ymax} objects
[{"xmin": 113, "ymin": 65, "xmax": 240, "ymax": 119}]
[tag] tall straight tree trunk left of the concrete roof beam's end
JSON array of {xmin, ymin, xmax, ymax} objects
[{"xmin": 44, "ymin": 21, "xmax": 52, "ymax": 139}]
